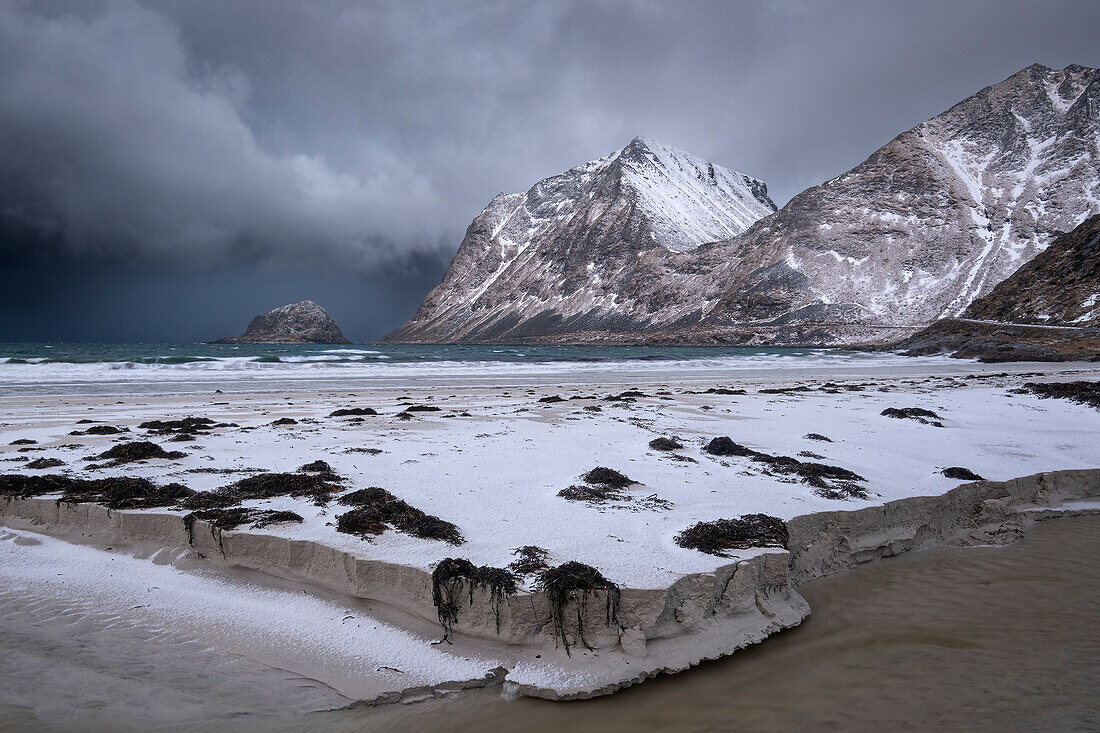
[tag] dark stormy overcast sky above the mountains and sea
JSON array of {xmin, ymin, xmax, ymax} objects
[{"xmin": 0, "ymin": 0, "xmax": 1100, "ymax": 341}]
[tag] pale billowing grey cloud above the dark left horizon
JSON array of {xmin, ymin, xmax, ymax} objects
[{"xmin": 0, "ymin": 1, "xmax": 441, "ymax": 266}]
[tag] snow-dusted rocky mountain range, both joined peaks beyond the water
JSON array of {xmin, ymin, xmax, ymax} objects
[{"xmin": 387, "ymin": 65, "xmax": 1100, "ymax": 344}]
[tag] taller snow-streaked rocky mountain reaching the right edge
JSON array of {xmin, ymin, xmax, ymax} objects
[{"xmin": 699, "ymin": 65, "xmax": 1100, "ymax": 342}]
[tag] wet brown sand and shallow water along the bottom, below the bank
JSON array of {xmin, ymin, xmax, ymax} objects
[{"xmin": 0, "ymin": 516, "xmax": 1100, "ymax": 733}]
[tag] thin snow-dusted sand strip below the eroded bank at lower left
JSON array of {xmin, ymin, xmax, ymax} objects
[{"xmin": 0, "ymin": 529, "xmax": 498, "ymax": 701}]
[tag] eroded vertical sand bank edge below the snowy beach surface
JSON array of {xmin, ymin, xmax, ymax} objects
[{"xmin": 0, "ymin": 469, "xmax": 1100, "ymax": 703}]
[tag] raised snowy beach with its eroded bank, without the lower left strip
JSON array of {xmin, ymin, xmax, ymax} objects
[{"xmin": 0, "ymin": 362, "xmax": 1100, "ymax": 702}]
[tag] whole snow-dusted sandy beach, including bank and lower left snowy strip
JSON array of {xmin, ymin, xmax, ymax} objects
[{"xmin": 0, "ymin": 359, "xmax": 1100, "ymax": 707}]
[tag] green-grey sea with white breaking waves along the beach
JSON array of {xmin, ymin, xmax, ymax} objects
[{"xmin": 0, "ymin": 343, "xmax": 958, "ymax": 395}]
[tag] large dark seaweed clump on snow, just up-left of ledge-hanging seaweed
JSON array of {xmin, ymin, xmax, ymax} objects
[{"xmin": 337, "ymin": 486, "xmax": 465, "ymax": 545}]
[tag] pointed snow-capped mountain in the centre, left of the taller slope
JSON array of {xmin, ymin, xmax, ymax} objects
[{"xmin": 387, "ymin": 138, "xmax": 776, "ymax": 341}]
